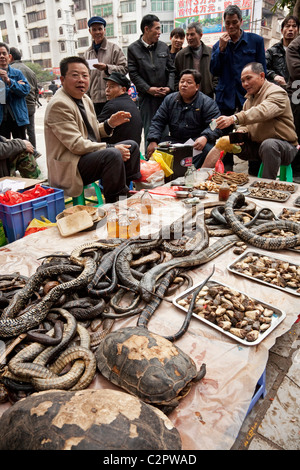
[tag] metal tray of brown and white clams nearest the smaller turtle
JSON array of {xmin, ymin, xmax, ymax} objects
[{"xmin": 173, "ymin": 281, "xmax": 286, "ymax": 346}]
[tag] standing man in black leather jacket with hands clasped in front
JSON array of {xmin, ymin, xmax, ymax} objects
[{"xmin": 128, "ymin": 14, "xmax": 175, "ymax": 149}]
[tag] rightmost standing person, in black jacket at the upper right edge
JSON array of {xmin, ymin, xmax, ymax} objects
[{"xmin": 266, "ymin": 16, "xmax": 300, "ymax": 87}]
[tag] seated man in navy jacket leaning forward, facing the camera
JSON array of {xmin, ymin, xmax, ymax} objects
[{"xmin": 147, "ymin": 69, "xmax": 222, "ymax": 168}]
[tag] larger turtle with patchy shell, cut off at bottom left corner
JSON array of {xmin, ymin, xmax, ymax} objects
[{"xmin": 0, "ymin": 389, "xmax": 182, "ymax": 450}]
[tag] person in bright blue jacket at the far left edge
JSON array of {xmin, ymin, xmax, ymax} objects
[{"xmin": 0, "ymin": 42, "xmax": 30, "ymax": 139}]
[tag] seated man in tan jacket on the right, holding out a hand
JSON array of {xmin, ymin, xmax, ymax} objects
[{"xmin": 203, "ymin": 62, "xmax": 298, "ymax": 179}]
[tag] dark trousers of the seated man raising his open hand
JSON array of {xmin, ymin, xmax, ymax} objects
[{"xmin": 78, "ymin": 140, "xmax": 141, "ymax": 203}]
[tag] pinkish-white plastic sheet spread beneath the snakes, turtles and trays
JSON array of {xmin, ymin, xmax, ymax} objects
[{"xmin": 0, "ymin": 170, "xmax": 299, "ymax": 450}]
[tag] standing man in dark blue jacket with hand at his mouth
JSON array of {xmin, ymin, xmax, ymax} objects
[{"xmin": 210, "ymin": 5, "xmax": 267, "ymax": 176}]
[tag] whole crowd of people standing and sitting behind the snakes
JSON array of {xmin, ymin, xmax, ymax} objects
[{"xmin": 0, "ymin": 5, "xmax": 300, "ymax": 202}]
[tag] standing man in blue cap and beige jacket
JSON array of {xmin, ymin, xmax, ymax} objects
[{"xmin": 84, "ymin": 16, "xmax": 128, "ymax": 114}]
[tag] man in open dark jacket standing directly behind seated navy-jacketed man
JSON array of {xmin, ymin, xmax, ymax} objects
[{"xmin": 175, "ymin": 22, "xmax": 218, "ymax": 98}]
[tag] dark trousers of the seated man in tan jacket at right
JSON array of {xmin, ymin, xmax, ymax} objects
[{"xmin": 239, "ymin": 139, "xmax": 298, "ymax": 180}]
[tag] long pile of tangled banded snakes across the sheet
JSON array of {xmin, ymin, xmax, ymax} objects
[{"xmin": 0, "ymin": 193, "xmax": 300, "ymax": 402}]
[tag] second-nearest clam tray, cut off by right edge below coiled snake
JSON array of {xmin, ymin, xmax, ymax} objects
[{"xmin": 227, "ymin": 251, "xmax": 300, "ymax": 296}]
